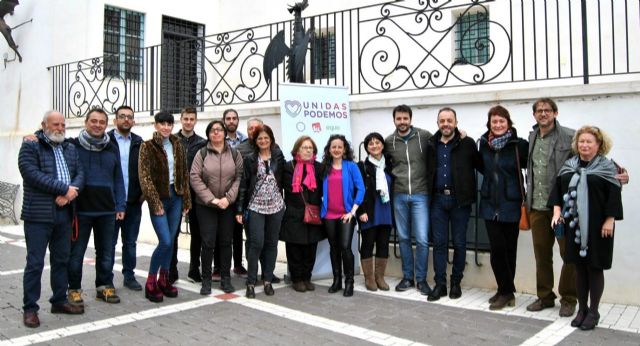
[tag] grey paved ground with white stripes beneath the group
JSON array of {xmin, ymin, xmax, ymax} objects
[{"xmin": 0, "ymin": 226, "xmax": 640, "ymax": 346}]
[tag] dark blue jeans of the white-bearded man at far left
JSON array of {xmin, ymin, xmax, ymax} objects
[{"xmin": 22, "ymin": 207, "xmax": 71, "ymax": 312}]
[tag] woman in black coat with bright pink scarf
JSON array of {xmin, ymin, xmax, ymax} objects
[{"xmin": 280, "ymin": 136, "xmax": 326, "ymax": 292}]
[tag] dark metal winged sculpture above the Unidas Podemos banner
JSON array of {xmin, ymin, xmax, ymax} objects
[{"xmin": 262, "ymin": 0, "xmax": 313, "ymax": 84}]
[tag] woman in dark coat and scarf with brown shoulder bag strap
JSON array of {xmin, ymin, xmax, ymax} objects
[{"xmin": 479, "ymin": 106, "xmax": 529, "ymax": 310}]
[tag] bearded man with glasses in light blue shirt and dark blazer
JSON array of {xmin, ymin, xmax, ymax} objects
[{"xmin": 108, "ymin": 105, "xmax": 143, "ymax": 291}]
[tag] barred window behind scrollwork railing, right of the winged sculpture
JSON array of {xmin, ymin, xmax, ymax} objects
[{"xmin": 455, "ymin": 12, "xmax": 489, "ymax": 65}]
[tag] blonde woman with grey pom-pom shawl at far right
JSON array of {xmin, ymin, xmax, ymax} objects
[{"xmin": 549, "ymin": 126, "xmax": 622, "ymax": 330}]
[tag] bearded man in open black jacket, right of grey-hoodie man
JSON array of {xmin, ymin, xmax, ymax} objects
[{"xmin": 427, "ymin": 107, "xmax": 481, "ymax": 301}]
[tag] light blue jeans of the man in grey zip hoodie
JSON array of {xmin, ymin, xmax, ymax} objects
[{"xmin": 393, "ymin": 193, "xmax": 429, "ymax": 282}]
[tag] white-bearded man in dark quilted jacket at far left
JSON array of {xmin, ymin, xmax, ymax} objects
[{"xmin": 18, "ymin": 111, "xmax": 84, "ymax": 328}]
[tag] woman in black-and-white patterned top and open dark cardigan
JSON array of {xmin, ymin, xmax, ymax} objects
[{"xmin": 236, "ymin": 125, "xmax": 284, "ymax": 298}]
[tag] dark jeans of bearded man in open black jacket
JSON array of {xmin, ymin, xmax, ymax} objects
[{"xmin": 431, "ymin": 194, "xmax": 471, "ymax": 286}]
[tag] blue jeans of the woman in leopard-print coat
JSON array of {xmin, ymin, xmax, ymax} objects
[{"xmin": 149, "ymin": 185, "xmax": 182, "ymax": 275}]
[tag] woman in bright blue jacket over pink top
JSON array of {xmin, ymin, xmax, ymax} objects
[{"xmin": 320, "ymin": 135, "xmax": 364, "ymax": 297}]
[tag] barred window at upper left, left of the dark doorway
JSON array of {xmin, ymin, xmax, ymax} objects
[{"xmin": 104, "ymin": 6, "xmax": 144, "ymax": 80}]
